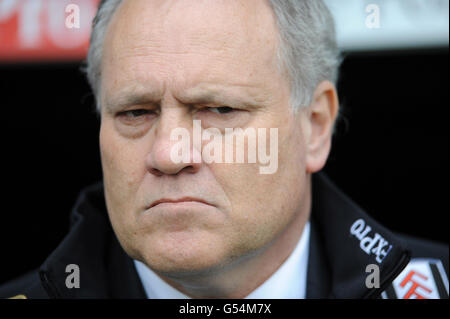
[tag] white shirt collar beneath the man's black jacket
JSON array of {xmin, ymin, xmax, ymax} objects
[{"xmin": 134, "ymin": 222, "xmax": 310, "ymax": 299}]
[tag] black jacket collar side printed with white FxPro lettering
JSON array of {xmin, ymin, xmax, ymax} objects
[{"xmin": 307, "ymin": 174, "xmax": 410, "ymax": 299}]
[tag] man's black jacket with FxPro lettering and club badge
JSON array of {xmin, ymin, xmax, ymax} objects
[{"xmin": 0, "ymin": 174, "xmax": 449, "ymax": 299}]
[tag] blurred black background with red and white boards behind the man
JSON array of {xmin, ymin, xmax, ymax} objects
[{"xmin": 0, "ymin": 0, "xmax": 449, "ymax": 284}]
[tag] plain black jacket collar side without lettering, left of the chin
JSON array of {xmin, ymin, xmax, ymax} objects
[{"xmin": 39, "ymin": 183, "xmax": 146, "ymax": 299}]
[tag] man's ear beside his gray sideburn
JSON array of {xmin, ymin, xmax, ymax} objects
[{"xmin": 306, "ymin": 81, "xmax": 339, "ymax": 173}]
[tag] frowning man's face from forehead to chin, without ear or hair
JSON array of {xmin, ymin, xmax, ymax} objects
[{"xmin": 100, "ymin": 0, "xmax": 308, "ymax": 274}]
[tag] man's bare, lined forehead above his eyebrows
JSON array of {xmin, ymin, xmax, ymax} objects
[{"xmin": 103, "ymin": 0, "xmax": 278, "ymax": 99}]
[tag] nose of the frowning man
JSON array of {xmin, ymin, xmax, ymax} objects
[{"xmin": 146, "ymin": 109, "xmax": 202, "ymax": 176}]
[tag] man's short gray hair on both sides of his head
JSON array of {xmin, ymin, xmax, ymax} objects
[{"xmin": 85, "ymin": 0, "xmax": 340, "ymax": 111}]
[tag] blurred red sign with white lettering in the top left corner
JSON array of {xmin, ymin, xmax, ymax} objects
[{"xmin": 0, "ymin": 0, "xmax": 100, "ymax": 63}]
